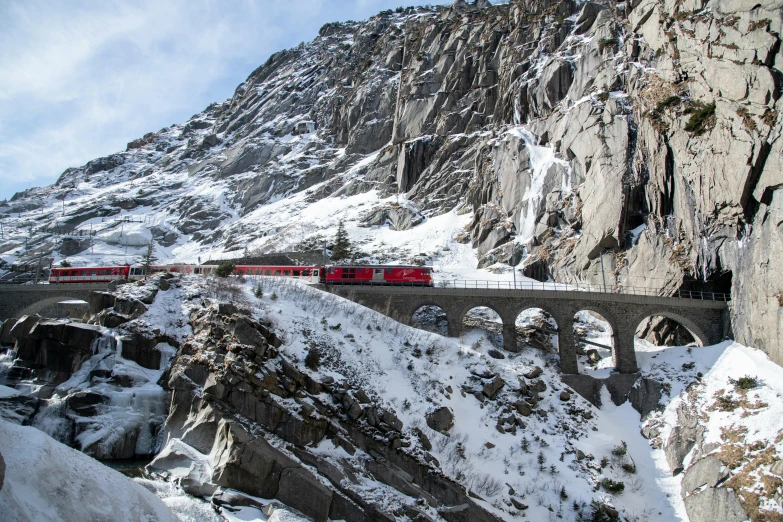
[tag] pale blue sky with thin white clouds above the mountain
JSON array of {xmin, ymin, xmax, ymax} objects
[{"xmin": 0, "ymin": 0, "xmax": 451, "ymax": 199}]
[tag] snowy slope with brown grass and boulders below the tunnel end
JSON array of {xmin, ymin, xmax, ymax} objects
[{"xmin": 639, "ymin": 342, "xmax": 783, "ymax": 522}]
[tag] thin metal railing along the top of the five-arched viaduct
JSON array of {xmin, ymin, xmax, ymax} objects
[{"xmin": 334, "ymin": 279, "xmax": 731, "ymax": 302}]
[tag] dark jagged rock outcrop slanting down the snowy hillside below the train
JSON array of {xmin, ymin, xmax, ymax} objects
[{"xmin": 150, "ymin": 305, "xmax": 495, "ymax": 521}]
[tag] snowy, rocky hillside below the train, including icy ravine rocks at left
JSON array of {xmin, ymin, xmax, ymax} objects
[{"xmin": 0, "ymin": 275, "xmax": 642, "ymax": 521}]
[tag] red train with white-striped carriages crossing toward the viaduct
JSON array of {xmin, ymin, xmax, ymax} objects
[{"xmin": 49, "ymin": 265, "xmax": 432, "ymax": 286}]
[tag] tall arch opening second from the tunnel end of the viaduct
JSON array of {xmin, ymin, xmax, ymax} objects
[{"xmin": 568, "ymin": 305, "xmax": 620, "ymax": 369}]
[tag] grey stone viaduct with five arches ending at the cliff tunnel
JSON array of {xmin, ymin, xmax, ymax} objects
[{"xmin": 320, "ymin": 285, "xmax": 728, "ymax": 374}]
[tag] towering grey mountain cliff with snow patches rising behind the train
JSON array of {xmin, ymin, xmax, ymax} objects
[{"xmin": 3, "ymin": 0, "xmax": 783, "ymax": 363}]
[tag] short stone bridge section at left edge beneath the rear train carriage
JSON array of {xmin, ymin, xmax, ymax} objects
[{"xmin": 0, "ymin": 283, "xmax": 108, "ymax": 321}]
